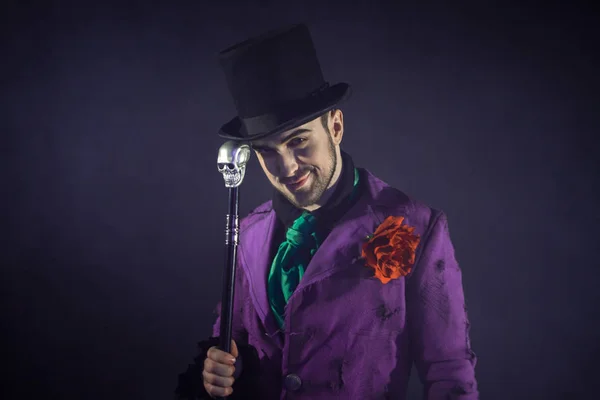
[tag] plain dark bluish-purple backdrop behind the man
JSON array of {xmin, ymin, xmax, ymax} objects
[{"xmin": 0, "ymin": 0, "xmax": 600, "ymax": 400}]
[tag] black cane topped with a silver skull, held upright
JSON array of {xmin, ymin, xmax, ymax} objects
[{"xmin": 217, "ymin": 140, "xmax": 251, "ymax": 399}]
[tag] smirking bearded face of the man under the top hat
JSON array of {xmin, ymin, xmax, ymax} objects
[{"xmin": 252, "ymin": 110, "xmax": 343, "ymax": 210}]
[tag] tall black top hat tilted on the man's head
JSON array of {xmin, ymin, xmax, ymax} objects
[{"xmin": 219, "ymin": 24, "xmax": 350, "ymax": 140}]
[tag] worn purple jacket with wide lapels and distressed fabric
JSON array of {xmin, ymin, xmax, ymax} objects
[{"xmin": 213, "ymin": 169, "xmax": 479, "ymax": 400}]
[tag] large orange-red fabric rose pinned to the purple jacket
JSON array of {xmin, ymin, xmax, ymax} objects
[{"xmin": 362, "ymin": 216, "xmax": 420, "ymax": 284}]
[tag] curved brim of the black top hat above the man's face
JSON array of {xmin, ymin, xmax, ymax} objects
[{"xmin": 218, "ymin": 82, "xmax": 352, "ymax": 141}]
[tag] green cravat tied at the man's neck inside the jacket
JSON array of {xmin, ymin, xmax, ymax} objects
[{"xmin": 267, "ymin": 169, "xmax": 359, "ymax": 328}]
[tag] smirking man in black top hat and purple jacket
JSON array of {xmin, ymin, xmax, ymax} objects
[{"xmin": 177, "ymin": 25, "xmax": 478, "ymax": 400}]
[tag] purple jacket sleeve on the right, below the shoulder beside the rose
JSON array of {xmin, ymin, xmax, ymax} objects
[{"xmin": 406, "ymin": 211, "xmax": 479, "ymax": 400}]
